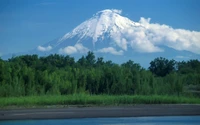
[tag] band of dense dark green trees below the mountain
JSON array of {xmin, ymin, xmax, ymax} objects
[{"xmin": 0, "ymin": 52, "xmax": 200, "ymax": 98}]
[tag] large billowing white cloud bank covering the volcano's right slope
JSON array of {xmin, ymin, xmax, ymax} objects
[{"xmin": 112, "ymin": 17, "xmax": 200, "ymax": 54}]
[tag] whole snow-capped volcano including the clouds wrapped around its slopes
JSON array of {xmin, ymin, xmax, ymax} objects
[{"xmin": 4, "ymin": 9, "xmax": 200, "ymax": 66}]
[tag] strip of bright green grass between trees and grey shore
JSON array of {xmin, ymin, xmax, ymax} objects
[{"xmin": 0, "ymin": 94, "xmax": 200, "ymax": 108}]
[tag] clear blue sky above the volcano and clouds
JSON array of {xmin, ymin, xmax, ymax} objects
[{"xmin": 0, "ymin": 0, "xmax": 200, "ymax": 55}]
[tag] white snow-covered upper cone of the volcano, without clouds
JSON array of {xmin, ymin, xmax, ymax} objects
[{"xmin": 60, "ymin": 10, "xmax": 142, "ymax": 44}]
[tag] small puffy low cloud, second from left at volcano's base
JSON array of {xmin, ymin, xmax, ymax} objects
[{"xmin": 59, "ymin": 43, "xmax": 89, "ymax": 55}]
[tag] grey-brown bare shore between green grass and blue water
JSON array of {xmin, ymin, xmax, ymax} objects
[{"xmin": 0, "ymin": 104, "xmax": 200, "ymax": 120}]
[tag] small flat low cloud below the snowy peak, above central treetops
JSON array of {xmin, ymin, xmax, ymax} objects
[{"xmin": 97, "ymin": 47, "xmax": 123, "ymax": 55}]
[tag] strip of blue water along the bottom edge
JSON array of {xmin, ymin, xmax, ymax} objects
[{"xmin": 0, "ymin": 116, "xmax": 200, "ymax": 125}]
